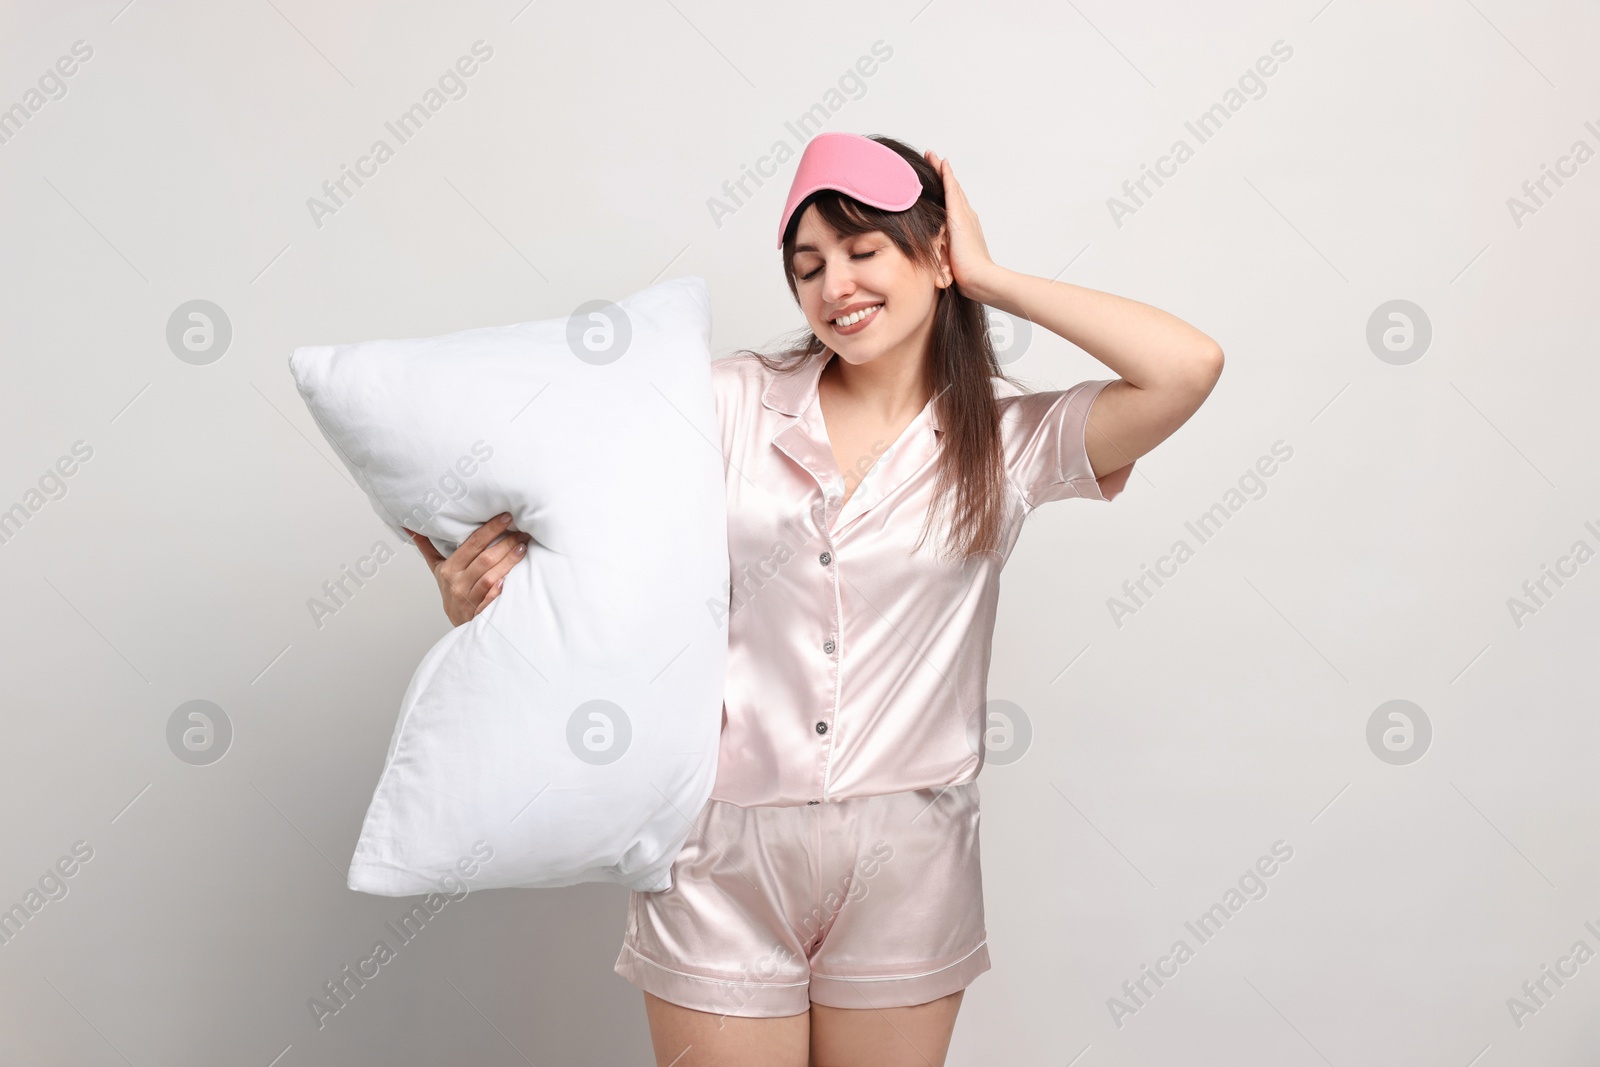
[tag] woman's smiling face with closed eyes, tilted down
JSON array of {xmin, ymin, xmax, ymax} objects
[{"xmin": 794, "ymin": 205, "xmax": 949, "ymax": 371}]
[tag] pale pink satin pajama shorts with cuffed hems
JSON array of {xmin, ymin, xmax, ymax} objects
[{"xmin": 613, "ymin": 781, "xmax": 989, "ymax": 1017}]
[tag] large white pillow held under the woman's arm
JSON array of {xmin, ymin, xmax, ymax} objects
[{"xmin": 290, "ymin": 277, "xmax": 728, "ymax": 896}]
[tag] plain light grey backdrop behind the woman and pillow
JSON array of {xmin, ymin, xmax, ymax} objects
[{"xmin": 0, "ymin": 0, "xmax": 1600, "ymax": 1067}]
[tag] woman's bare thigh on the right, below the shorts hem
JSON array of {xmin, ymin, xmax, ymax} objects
[{"xmin": 808, "ymin": 989, "xmax": 966, "ymax": 1067}]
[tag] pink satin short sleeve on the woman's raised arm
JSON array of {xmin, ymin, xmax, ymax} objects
[{"xmin": 1002, "ymin": 378, "xmax": 1133, "ymax": 509}]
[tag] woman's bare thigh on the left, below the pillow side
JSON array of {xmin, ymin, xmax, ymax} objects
[{"xmin": 645, "ymin": 993, "xmax": 812, "ymax": 1067}]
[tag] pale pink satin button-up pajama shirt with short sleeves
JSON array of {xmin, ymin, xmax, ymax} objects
[{"xmin": 710, "ymin": 350, "xmax": 1133, "ymax": 806}]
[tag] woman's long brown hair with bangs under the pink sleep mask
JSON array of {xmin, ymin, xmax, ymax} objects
[{"xmin": 741, "ymin": 136, "xmax": 1014, "ymax": 561}]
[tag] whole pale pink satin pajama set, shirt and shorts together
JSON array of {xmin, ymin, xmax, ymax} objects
[{"xmin": 613, "ymin": 350, "xmax": 1133, "ymax": 1017}]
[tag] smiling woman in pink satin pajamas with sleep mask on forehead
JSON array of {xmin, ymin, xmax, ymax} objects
[{"xmin": 414, "ymin": 133, "xmax": 1222, "ymax": 1067}]
